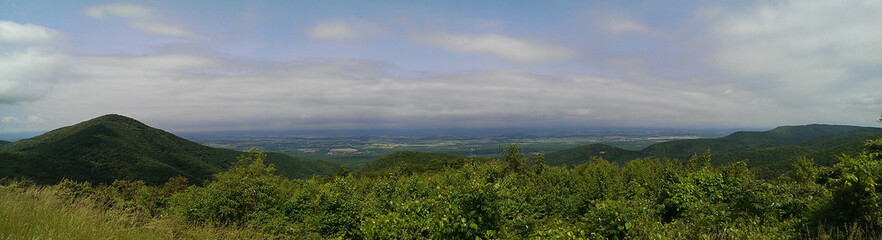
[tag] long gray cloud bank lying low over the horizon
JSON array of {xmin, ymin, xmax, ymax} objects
[{"xmin": 12, "ymin": 48, "xmax": 769, "ymax": 130}]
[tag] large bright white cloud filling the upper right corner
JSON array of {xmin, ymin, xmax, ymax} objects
[{"xmin": 697, "ymin": 0, "xmax": 882, "ymax": 93}]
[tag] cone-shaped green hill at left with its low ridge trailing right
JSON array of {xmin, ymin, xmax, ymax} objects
[{"xmin": 0, "ymin": 115, "xmax": 336, "ymax": 184}]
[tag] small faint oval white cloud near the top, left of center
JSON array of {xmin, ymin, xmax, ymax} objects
[{"xmin": 307, "ymin": 20, "xmax": 385, "ymax": 40}]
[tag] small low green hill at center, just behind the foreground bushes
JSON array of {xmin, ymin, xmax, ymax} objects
[{"xmin": 359, "ymin": 151, "xmax": 467, "ymax": 176}]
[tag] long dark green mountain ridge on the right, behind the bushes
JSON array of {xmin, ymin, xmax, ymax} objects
[{"xmin": 545, "ymin": 124, "xmax": 882, "ymax": 178}]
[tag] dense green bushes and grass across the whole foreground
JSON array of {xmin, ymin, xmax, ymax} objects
[{"xmin": 0, "ymin": 141, "xmax": 882, "ymax": 239}]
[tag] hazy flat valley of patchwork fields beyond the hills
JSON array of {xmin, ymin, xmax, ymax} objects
[{"xmin": 180, "ymin": 129, "xmax": 733, "ymax": 169}]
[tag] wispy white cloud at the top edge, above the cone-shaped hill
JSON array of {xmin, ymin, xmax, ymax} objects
[{"xmin": 83, "ymin": 3, "xmax": 200, "ymax": 37}]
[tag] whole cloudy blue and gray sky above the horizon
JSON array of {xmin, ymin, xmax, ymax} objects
[{"xmin": 0, "ymin": 0, "xmax": 882, "ymax": 137}]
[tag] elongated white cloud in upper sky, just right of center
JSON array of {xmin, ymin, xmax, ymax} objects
[{"xmin": 416, "ymin": 32, "xmax": 574, "ymax": 63}]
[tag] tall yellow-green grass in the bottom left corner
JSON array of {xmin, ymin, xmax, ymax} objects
[{"xmin": 0, "ymin": 185, "xmax": 274, "ymax": 239}]
